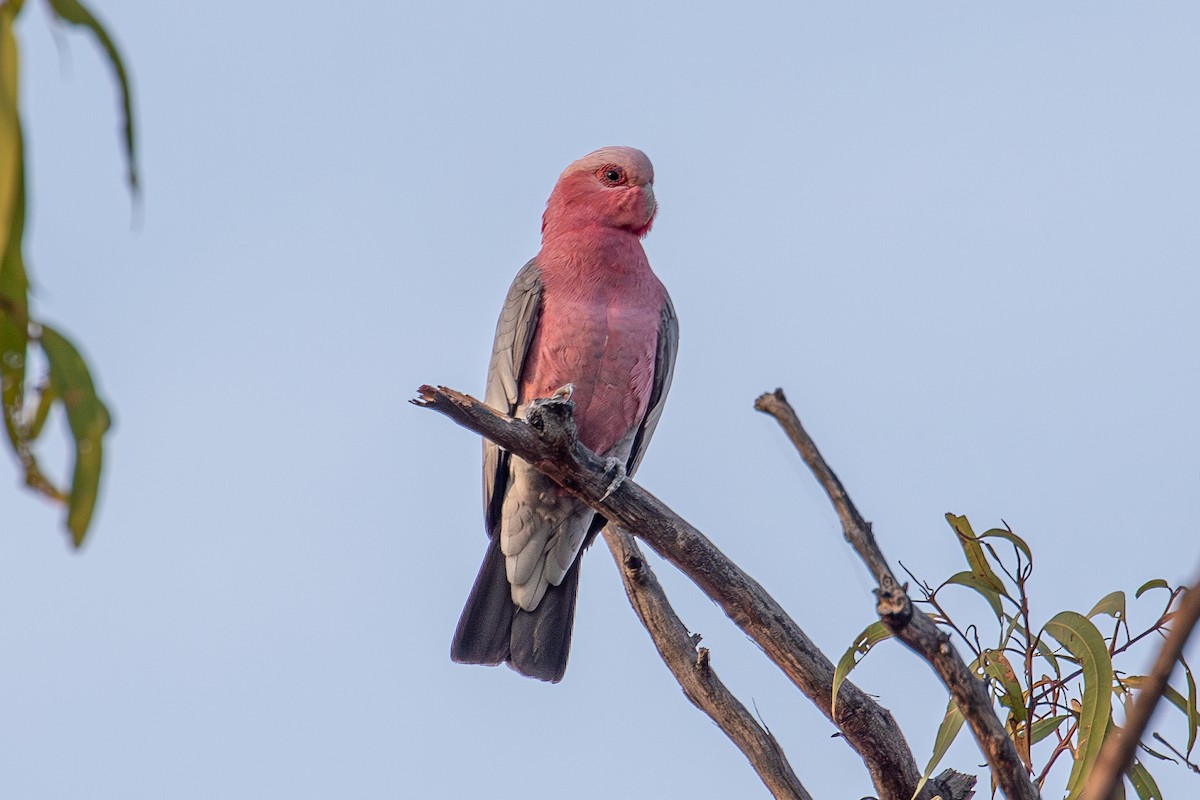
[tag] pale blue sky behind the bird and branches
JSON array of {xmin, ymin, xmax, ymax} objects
[{"xmin": 0, "ymin": 0, "xmax": 1200, "ymax": 800}]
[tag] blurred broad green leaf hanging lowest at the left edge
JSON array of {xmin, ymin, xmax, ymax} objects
[{"xmin": 41, "ymin": 325, "xmax": 110, "ymax": 547}]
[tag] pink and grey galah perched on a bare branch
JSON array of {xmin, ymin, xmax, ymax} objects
[{"xmin": 450, "ymin": 148, "xmax": 679, "ymax": 682}]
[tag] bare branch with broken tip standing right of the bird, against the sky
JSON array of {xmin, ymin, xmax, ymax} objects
[{"xmin": 755, "ymin": 389, "xmax": 1038, "ymax": 800}]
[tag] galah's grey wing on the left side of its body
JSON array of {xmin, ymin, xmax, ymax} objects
[{"xmin": 484, "ymin": 259, "xmax": 541, "ymax": 536}]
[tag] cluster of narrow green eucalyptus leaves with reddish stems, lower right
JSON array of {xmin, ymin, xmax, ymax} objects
[{"xmin": 834, "ymin": 513, "xmax": 1200, "ymax": 800}]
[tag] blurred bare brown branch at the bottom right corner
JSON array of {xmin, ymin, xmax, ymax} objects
[{"xmin": 1082, "ymin": 566, "xmax": 1200, "ymax": 800}]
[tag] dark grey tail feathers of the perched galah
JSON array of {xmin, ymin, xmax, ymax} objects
[{"xmin": 450, "ymin": 540, "xmax": 582, "ymax": 684}]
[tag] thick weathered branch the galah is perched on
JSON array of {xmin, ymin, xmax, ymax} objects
[{"xmin": 413, "ymin": 386, "xmax": 964, "ymax": 800}]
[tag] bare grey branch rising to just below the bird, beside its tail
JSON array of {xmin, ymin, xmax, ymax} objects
[{"xmin": 604, "ymin": 525, "xmax": 812, "ymax": 800}]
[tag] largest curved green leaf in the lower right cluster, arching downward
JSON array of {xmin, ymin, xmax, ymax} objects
[{"xmin": 1044, "ymin": 612, "xmax": 1112, "ymax": 800}]
